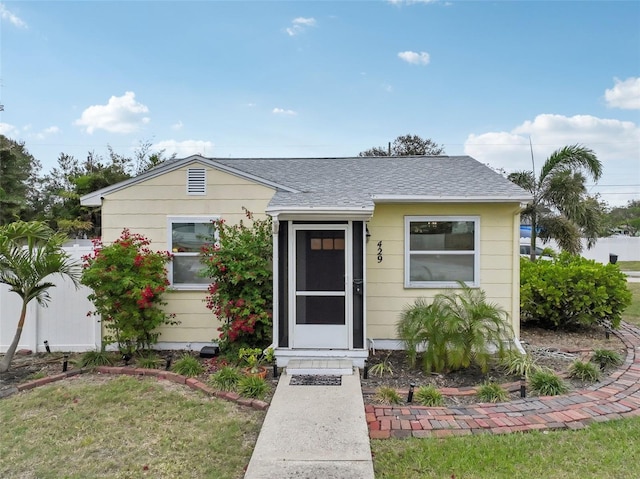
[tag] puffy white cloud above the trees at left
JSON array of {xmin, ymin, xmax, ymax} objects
[{"xmin": 74, "ymin": 91, "xmax": 150, "ymax": 134}]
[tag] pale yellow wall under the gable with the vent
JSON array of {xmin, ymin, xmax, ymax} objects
[{"xmin": 102, "ymin": 162, "xmax": 275, "ymax": 343}]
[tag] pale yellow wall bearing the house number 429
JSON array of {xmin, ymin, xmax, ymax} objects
[{"xmin": 367, "ymin": 203, "xmax": 520, "ymax": 339}]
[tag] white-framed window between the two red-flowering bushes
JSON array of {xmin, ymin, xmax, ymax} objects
[{"xmin": 168, "ymin": 216, "xmax": 218, "ymax": 289}]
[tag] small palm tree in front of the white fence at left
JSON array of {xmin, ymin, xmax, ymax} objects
[{"xmin": 0, "ymin": 221, "xmax": 81, "ymax": 372}]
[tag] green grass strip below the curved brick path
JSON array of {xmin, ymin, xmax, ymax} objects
[{"xmin": 371, "ymin": 418, "xmax": 640, "ymax": 479}]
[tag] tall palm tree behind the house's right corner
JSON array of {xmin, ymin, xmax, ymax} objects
[{"xmin": 509, "ymin": 145, "xmax": 603, "ymax": 260}]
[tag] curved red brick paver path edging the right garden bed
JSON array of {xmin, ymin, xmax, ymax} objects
[{"xmin": 365, "ymin": 323, "xmax": 640, "ymax": 439}]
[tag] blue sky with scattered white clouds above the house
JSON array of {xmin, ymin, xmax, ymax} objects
[{"xmin": 0, "ymin": 0, "xmax": 640, "ymax": 205}]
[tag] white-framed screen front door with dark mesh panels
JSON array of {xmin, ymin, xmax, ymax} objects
[{"xmin": 290, "ymin": 225, "xmax": 351, "ymax": 349}]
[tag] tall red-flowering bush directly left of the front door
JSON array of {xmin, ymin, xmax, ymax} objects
[{"xmin": 201, "ymin": 208, "xmax": 273, "ymax": 352}]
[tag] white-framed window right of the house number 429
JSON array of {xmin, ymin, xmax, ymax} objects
[{"xmin": 404, "ymin": 216, "xmax": 480, "ymax": 288}]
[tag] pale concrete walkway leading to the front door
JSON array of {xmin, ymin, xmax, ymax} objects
[{"xmin": 245, "ymin": 374, "xmax": 374, "ymax": 479}]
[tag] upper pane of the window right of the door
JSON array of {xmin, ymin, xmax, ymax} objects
[{"xmin": 409, "ymin": 221, "xmax": 475, "ymax": 251}]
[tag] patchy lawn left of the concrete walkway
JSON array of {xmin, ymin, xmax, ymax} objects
[{"xmin": 0, "ymin": 376, "xmax": 264, "ymax": 479}]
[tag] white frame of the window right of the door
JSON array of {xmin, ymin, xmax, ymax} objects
[{"xmin": 404, "ymin": 216, "xmax": 480, "ymax": 288}]
